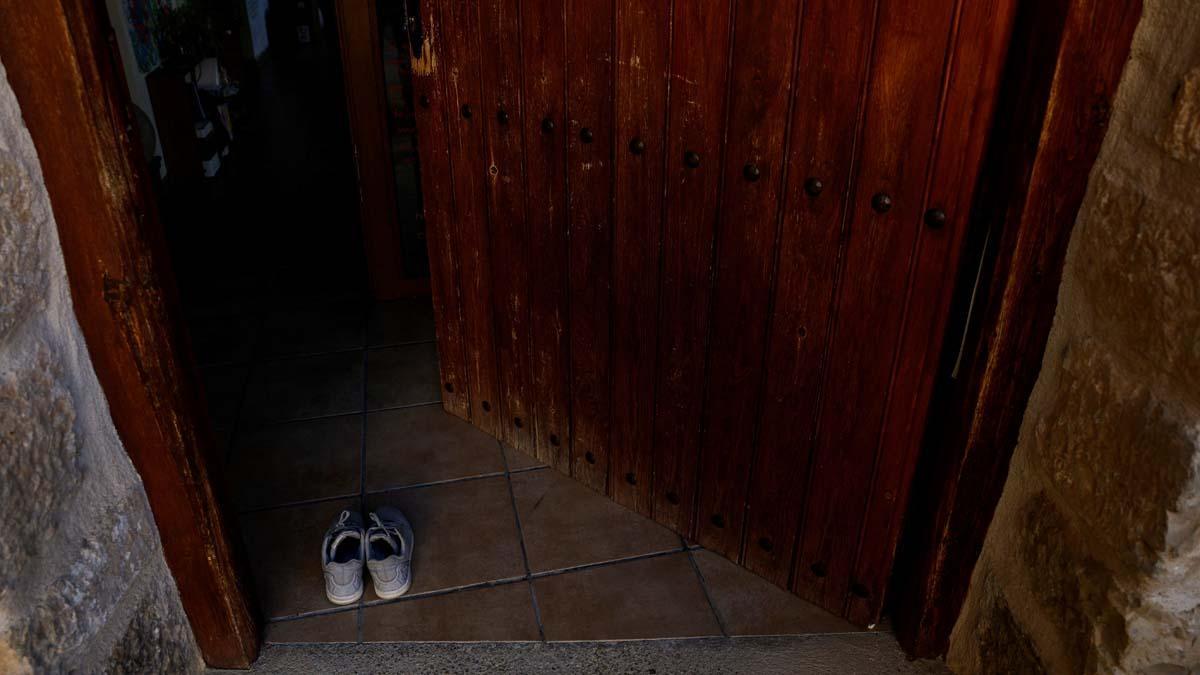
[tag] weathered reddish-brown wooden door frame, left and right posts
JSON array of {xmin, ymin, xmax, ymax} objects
[{"xmin": 0, "ymin": 0, "xmax": 1141, "ymax": 668}]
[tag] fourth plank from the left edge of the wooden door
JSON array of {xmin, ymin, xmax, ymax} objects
[{"xmin": 521, "ymin": 0, "xmax": 571, "ymax": 473}]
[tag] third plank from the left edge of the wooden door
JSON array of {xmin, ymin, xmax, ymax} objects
[{"xmin": 475, "ymin": 0, "xmax": 534, "ymax": 450}]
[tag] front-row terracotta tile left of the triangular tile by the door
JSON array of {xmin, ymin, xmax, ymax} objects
[{"xmin": 533, "ymin": 552, "xmax": 721, "ymax": 640}]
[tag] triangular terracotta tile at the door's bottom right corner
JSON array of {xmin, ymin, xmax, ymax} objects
[{"xmin": 692, "ymin": 549, "xmax": 857, "ymax": 635}]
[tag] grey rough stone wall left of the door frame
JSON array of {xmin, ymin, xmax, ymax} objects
[{"xmin": 0, "ymin": 60, "xmax": 202, "ymax": 673}]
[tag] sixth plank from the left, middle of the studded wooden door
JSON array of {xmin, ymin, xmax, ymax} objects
[{"xmin": 610, "ymin": 0, "xmax": 671, "ymax": 515}]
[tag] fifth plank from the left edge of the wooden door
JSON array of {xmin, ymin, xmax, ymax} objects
[{"xmin": 565, "ymin": 0, "xmax": 613, "ymax": 492}]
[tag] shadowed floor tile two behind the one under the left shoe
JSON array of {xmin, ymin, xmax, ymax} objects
[{"xmin": 244, "ymin": 352, "xmax": 362, "ymax": 424}]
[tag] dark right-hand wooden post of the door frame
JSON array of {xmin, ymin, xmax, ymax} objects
[{"xmin": 889, "ymin": 0, "xmax": 1141, "ymax": 657}]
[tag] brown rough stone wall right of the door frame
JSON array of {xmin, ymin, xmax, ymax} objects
[{"xmin": 948, "ymin": 0, "xmax": 1200, "ymax": 674}]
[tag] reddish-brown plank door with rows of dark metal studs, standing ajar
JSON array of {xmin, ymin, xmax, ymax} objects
[{"xmin": 403, "ymin": 0, "xmax": 1015, "ymax": 625}]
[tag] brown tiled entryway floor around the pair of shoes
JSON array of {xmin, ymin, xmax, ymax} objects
[{"xmin": 193, "ymin": 299, "xmax": 854, "ymax": 643}]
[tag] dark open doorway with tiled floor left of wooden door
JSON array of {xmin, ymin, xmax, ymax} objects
[{"xmin": 108, "ymin": 0, "xmax": 856, "ymax": 643}]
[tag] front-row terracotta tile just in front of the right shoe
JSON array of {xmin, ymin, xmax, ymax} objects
[{"xmin": 362, "ymin": 581, "xmax": 539, "ymax": 643}]
